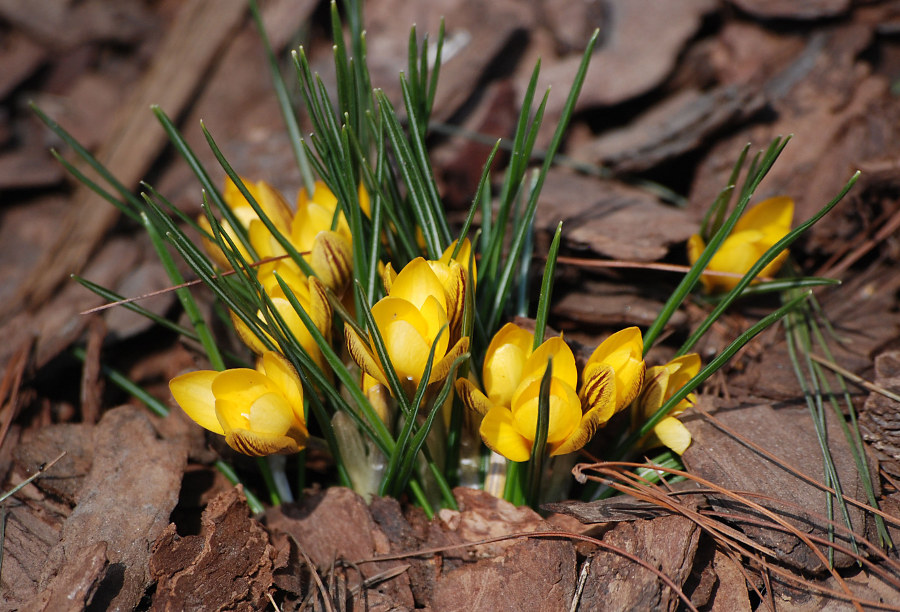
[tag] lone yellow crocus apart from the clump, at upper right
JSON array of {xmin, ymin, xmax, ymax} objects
[{"xmin": 687, "ymin": 196, "xmax": 794, "ymax": 293}]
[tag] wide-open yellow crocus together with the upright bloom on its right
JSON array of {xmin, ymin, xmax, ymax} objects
[{"xmin": 456, "ymin": 323, "xmax": 644, "ymax": 461}]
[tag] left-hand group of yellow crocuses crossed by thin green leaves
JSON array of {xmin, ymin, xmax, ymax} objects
[{"xmin": 169, "ymin": 180, "xmax": 360, "ymax": 456}]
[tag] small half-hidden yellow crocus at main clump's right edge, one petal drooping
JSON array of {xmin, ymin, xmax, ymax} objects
[{"xmin": 636, "ymin": 353, "xmax": 700, "ymax": 455}]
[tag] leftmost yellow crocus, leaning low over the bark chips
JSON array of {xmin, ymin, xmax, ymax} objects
[{"xmin": 169, "ymin": 351, "xmax": 309, "ymax": 457}]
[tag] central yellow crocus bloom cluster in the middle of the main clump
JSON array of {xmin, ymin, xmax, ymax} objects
[{"xmin": 344, "ymin": 245, "xmax": 469, "ymax": 397}]
